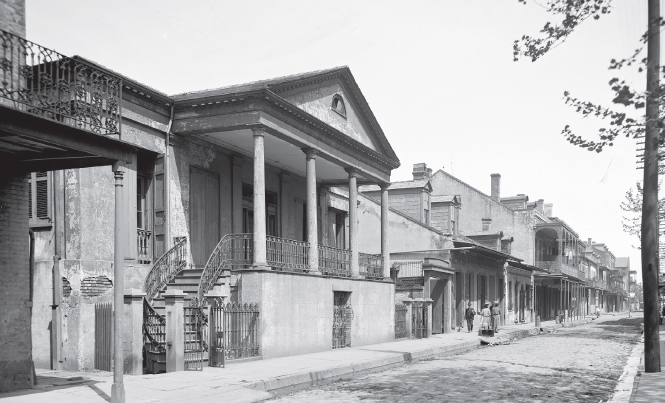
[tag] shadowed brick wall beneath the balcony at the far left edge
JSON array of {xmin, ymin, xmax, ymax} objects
[{"xmin": 0, "ymin": 175, "xmax": 32, "ymax": 392}]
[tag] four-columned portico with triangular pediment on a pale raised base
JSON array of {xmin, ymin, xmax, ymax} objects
[{"xmin": 170, "ymin": 67, "xmax": 399, "ymax": 357}]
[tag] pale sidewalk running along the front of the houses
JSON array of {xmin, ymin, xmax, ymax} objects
[{"xmin": 0, "ymin": 317, "xmax": 602, "ymax": 403}]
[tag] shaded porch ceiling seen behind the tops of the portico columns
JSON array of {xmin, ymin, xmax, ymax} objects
[{"xmin": 198, "ymin": 129, "xmax": 362, "ymax": 183}]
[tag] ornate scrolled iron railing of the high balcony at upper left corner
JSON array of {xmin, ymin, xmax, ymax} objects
[{"xmin": 0, "ymin": 30, "xmax": 122, "ymax": 135}]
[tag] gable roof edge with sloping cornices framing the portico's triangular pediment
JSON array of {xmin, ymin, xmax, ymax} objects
[{"xmin": 172, "ymin": 66, "xmax": 400, "ymax": 167}]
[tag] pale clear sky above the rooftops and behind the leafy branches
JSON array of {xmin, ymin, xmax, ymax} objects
[{"xmin": 26, "ymin": 0, "xmax": 647, "ymax": 281}]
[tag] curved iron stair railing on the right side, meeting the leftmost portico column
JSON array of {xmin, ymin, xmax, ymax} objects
[{"xmin": 198, "ymin": 234, "xmax": 253, "ymax": 301}]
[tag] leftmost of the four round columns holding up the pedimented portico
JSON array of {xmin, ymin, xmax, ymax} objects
[{"xmin": 252, "ymin": 127, "xmax": 268, "ymax": 269}]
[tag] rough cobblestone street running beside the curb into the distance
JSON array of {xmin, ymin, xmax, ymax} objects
[{"xmin": 271, "ymin": 316, "xmax": 643, "ymax": 403}]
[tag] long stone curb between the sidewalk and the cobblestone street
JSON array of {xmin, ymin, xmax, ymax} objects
[{"xmin": 242, "ymin": 320, "xmax": 591, "ymax": 394}]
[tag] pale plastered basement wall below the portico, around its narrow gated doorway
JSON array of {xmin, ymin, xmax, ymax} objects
[{"xmin": 240, "ymin": 271, "xmax": 395, "ymax": 358}]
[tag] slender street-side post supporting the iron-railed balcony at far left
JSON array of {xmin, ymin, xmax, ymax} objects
[{"xmin": 111, "ymin": 161, "xmax": 126, "ymax": 403}]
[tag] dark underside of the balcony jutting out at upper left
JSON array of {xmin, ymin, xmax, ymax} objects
[{"xmin": 0, "ymin": 103, "xmax": 151, "ymax": 172}]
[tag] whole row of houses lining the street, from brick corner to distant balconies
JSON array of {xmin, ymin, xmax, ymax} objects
[{"xmin": 0, "ymin": 1, "xmax": 629, "ymax": 391}]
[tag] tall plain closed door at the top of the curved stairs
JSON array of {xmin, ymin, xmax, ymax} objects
[{"xmin": 189, "ymin": 167, "xmax": 220, "ymax": 268}]
